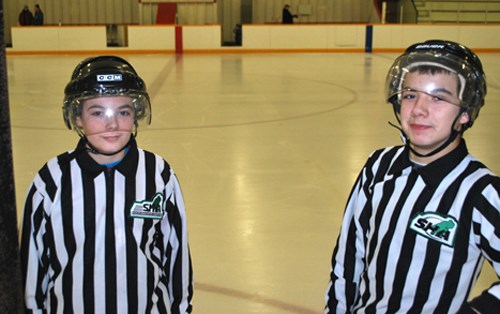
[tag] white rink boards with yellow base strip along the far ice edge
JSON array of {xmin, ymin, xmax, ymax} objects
[{"xmin": 7, "ymin": 24, "xmax": 500, "ymax": 54}]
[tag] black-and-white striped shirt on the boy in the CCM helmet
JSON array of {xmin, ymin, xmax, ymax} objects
[{"xmin": 21, "ymin": 139, "xmax": 193, "ymax": 314}]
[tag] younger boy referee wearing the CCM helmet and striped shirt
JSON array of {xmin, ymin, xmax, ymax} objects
[{"xmin": 21, "ymin": 56, "xmax": 193, "ymax": 314}]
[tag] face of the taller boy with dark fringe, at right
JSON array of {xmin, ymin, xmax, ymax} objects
[{"xmin": 400, "ymin": 71, "xmax": 469, "ymax": 158}]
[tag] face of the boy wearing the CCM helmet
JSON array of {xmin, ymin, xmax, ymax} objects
[{"xmin": 76, "ymin": 96, "xmax": 135, "ymax": 159}]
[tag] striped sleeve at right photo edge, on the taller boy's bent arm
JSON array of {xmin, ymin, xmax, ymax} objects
[{"xmin": 470, "ymin": 177, "xmax": 500, "ymax": 314}]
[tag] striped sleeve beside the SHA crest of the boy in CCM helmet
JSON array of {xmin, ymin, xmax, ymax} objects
[{"xmin": 165, "ymin": 171, "xmax": 193, "ymax": 314}]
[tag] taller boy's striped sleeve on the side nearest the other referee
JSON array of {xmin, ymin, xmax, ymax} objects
[{"xmin": 324, "ymin": 168, "xmax": 367, "ymax": 314}]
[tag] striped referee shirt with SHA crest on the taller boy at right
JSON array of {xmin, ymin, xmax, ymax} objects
[{"xmin": 324, "ymin": 140, "xmax": 500, "ymax": 313}]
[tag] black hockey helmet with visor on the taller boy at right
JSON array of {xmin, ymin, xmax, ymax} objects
[{"xmin": 386, "ymin": 40, "xmax": 486, "ymax": 130}]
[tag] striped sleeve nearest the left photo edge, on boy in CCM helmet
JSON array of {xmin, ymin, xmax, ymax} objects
[{"xmin": 20, "ymin": 180, "xmax": 49, "ymax": 313}]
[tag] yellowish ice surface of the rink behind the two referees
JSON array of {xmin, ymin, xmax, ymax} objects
[{"xmin": 7, "ymin": 53, "xmax": 500, "ymax": 314}]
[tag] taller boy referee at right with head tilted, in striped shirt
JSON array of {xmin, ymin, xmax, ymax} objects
[{"xmin": 324, "ymin": 40, "xmax": 500, "ymax": 313}]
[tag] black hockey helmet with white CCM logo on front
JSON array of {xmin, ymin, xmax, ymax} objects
[{"xmin": 63, "ymin": 56, "xmax": 151, "ymax": 136}]
